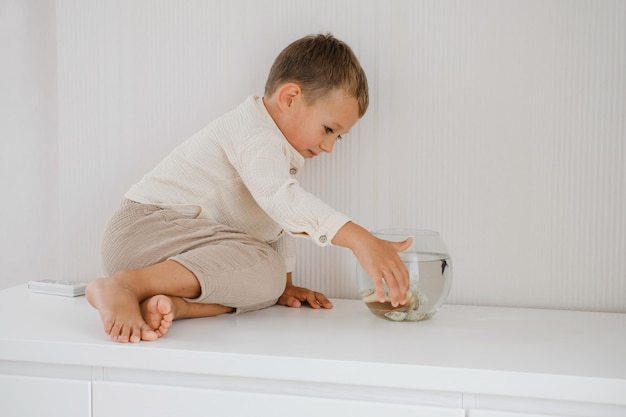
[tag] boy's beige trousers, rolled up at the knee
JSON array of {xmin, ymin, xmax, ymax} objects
[{"xmin": 102, "ymin": 200, "xmax": 286, "ymax": 313}]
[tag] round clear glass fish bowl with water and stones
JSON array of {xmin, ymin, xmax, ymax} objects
[{"xmin": 357, "ymin": 229, "xmax": 452, "ymax": 321}]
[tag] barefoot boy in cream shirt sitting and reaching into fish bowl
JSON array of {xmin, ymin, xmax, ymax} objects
[{"xmin": 86, "ymin": 34, "xmax": 410, "ymax": 342}]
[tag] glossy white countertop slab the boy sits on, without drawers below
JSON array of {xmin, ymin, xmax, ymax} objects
[{"xmin": 0, "ymin": 285, "xmax": 626, "ymax": 405}]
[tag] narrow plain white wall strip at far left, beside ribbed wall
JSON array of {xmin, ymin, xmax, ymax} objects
[{"xmin": 0, "ymin": 0, "xmax": 60, "ymax": 288}]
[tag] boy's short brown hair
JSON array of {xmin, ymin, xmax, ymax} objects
[{"xmin": 265, "ymin": 33, "xmax": 369, "ymax": 117}]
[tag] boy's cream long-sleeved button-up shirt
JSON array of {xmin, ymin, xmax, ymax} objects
[{"xmin": 125, "ymin": 96, "xmax": 350, "ymax": 272}]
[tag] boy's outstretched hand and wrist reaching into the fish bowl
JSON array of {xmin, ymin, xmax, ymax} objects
[{"xmin": 332, "ymin": 222, "xmax": 411, "ymax": 307}]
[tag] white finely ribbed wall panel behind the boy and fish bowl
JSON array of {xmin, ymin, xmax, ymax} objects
[{"xmin": 3, "ymin": 0, "xmax": 626, "ymax": 311}]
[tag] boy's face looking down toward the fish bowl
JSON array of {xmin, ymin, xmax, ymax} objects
[{"xmin": 281, "ymin": 90, "xmax": 359, "ymax": 158}]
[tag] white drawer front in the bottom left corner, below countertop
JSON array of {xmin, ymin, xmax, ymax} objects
[{"xmin": 0, "ymin": 375, "xmax": 91, "ymax": 417}]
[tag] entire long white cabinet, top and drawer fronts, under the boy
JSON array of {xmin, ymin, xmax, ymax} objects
[{"xmin": 0, "ymin": 286, "xmax": 626, "ymax": 417}]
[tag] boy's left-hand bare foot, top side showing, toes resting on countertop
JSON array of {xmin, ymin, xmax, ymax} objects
[{"xmin": 86, "ymin": 272, "xmax": 159, "ymax": 343}]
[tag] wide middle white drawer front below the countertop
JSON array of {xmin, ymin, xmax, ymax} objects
[{"xmin": 93, "ymin": 381, "xmax": 465, "ymax": 417}]
